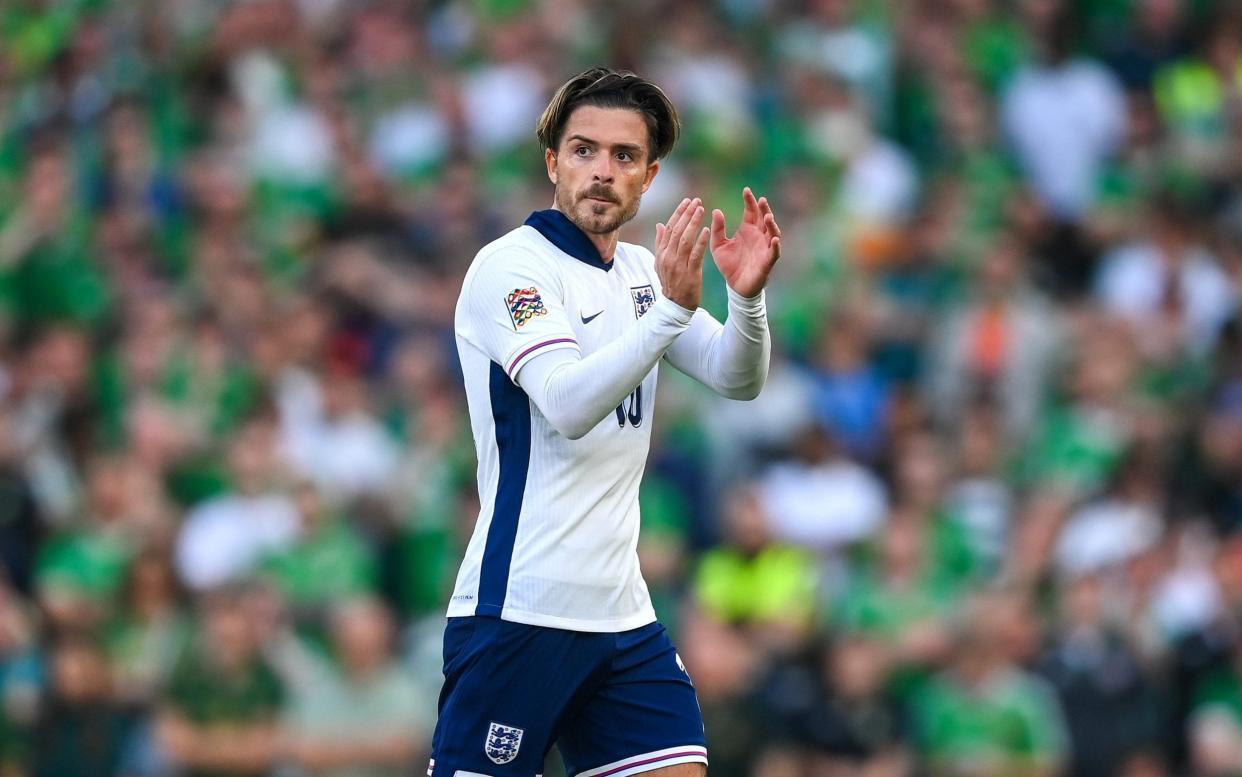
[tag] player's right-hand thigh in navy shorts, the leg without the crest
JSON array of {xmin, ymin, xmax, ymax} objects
[{"xmin": 559, "ymin": 623, "xmax": 707, "ymax": 777}]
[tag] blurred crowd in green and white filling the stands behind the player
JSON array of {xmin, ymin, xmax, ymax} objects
[{"xmin": 0, "ymin": 0, "xmax": 1242, "ymax": 777}]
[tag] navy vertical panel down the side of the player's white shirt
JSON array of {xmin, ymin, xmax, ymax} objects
[{"xmin": 474, "ymin": 361, "xmax": 530, "ymax": 618}]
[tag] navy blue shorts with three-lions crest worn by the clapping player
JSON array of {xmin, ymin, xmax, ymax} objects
[{"xmin": 427, "ymin": 616, "xmax": 707, "ymax": 777}]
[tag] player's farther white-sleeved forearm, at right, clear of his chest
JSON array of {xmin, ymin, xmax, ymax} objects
[{"xmin": 668, "ymin": 289, "xmax": 771, "ymax": 400}]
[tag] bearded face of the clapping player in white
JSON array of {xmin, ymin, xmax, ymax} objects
[{"xmin": 545, "ymin": 106, "xmax": 660, "ymax": 235}]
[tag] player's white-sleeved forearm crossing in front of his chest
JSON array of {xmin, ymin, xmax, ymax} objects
[{"xmin": 517, "ymin": 299, "xmax": 693, "ymax": 439}]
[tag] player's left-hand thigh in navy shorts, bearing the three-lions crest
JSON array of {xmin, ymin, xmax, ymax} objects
[{"xmin": 427, "ymin": 617, "xmax": 611, "ymax": 777}]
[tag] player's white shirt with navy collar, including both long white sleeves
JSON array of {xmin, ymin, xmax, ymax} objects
[{"xmin": 448, "ymin": 210, "xmax": 770, "ymax": 632}]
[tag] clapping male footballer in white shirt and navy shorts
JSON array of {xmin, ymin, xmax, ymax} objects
[{"xmin": 427, "ymin": 68, "xmax": 780, "ymax": 777}]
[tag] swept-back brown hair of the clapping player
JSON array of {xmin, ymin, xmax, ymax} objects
[{"xmin": 535, "ymin": 67, "xmax": 682, "ymax": 161}]
